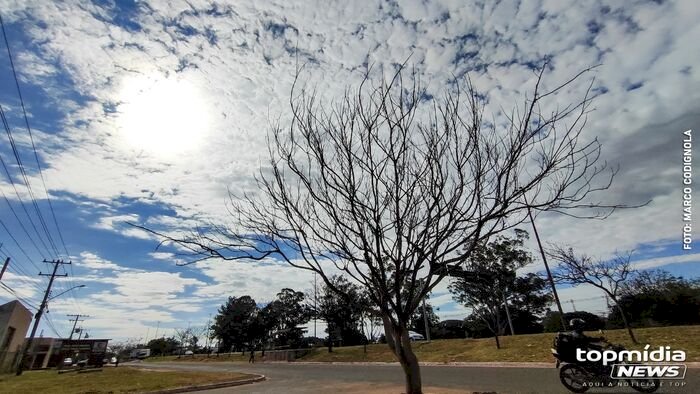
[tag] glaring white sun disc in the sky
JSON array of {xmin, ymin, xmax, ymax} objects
[{"xmin": 117, "ymin": 74, "xmax": 209, "ymax": 158}]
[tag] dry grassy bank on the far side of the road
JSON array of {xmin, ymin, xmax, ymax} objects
[{"xmin": 302, "ymin": 326, "xmax": 700, "ymax": 362}]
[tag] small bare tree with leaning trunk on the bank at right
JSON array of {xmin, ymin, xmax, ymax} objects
[{"xmin": 548, "ymin": 246, "xmax": 637, "ymax": 344}]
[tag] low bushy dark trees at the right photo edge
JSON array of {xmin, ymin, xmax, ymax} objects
[{"xmin": 608, "ymin": 270, "xmax": 700, "ymax": 327}]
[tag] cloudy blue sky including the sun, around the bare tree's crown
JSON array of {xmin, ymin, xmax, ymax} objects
[{"xmin": 0, "ymin": 0, "xmax": 700, "ymax": 340}]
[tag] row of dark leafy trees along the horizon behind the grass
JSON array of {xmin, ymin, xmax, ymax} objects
[{"xmin": 205, "ymin": 230, "xmax": 700, "ymax": 351}]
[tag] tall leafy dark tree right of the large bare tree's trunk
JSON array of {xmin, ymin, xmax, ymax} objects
[{"xmin": 449, "ymin": 229, "xmax": 550, "ymax": 349}]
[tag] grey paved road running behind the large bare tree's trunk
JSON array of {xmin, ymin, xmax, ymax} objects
[{"xmin": 134, "ymin": 362, "xmax": 700, "ymax": 394}]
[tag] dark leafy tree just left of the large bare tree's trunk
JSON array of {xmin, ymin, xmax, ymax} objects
[{"xmin": 315, "ymin": 275, "xmax": 369, "ymax": 353}]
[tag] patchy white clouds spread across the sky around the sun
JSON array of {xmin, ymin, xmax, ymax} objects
[{"xmin": 0, "ymin": 0, "xmax": 700, "ymax": 338}]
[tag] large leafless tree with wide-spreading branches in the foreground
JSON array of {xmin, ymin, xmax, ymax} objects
[{"xmin": 133, "ymin": 65, "xmax": 615, "ymax": 394}]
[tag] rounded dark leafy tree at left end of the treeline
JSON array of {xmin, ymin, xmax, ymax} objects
[{"xmin": 211, "ymin": 295, "xmax": 258, "ymax": 351}]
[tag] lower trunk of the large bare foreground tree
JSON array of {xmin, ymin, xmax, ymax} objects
[{"xmin": 382, "ymin": 317, "xmax": 423, "ymax": 394}]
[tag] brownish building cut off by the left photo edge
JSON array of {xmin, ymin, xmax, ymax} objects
[{"xmin": 0, "ymin": 300, "xmax": 32, "ymax": 372}]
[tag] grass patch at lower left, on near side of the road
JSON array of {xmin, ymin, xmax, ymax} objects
[{"xmin": 0, "ymin": 367, "xmax": 253, "ymax": 394}]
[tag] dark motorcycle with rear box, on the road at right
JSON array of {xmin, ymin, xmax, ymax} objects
[{"xmin": 551, "ymin": 333, "xmax": 660, "ymax": 393}]
